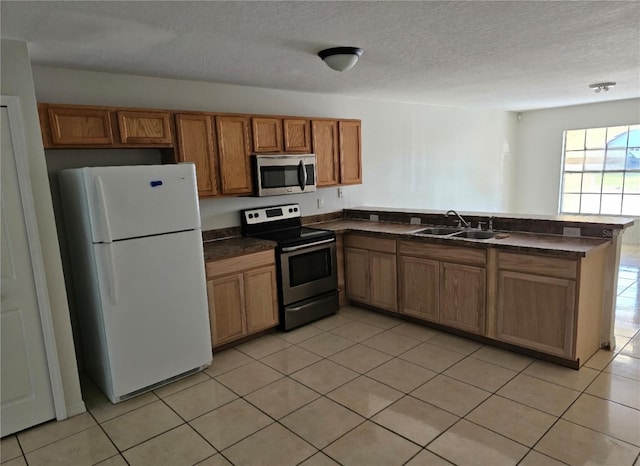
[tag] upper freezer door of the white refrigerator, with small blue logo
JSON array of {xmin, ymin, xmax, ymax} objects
[{"xmin": 81, "ymin": 164, "xmax": 200, "ymax": 243}]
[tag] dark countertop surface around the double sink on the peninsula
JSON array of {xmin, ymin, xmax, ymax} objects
[{"xmin": 313, "ymin": 220, "xmax": 611, "ymax": 257}]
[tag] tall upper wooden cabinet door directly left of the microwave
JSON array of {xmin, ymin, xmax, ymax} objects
[{"xmin": 216, "ymin": 115, "xmax": 252, "ymax": 194}]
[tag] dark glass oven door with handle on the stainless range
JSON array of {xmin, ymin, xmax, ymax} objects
[{"xmin": 280, "ymin": 238, "xmax": 338, "ymax": 306}]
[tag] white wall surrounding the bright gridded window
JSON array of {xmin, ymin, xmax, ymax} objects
[{"xmin": 513, "ymin": 98, "xmax": 640, "ymax": 244}]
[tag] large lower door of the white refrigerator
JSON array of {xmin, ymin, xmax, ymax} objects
[{"xmin": 93, "ymin": 230, "xmax": 212, "ymax": 397}]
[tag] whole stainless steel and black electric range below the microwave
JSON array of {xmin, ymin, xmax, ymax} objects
[{"xmin": 241, "ymin": 204, "xmax": 340, "ymax": 330}]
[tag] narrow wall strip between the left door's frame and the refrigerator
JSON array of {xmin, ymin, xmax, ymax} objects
[{"xmin": 0, "ymin": 39, "xmax": 84, "ymax": 415}]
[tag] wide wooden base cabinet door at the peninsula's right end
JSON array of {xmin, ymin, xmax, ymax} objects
[{"xmin": 497, "ymin": 270, "xmax": 576, "ymax": 358}]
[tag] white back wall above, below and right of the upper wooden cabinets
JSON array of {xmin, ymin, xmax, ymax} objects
[{"xmin": 33, "ymin": 66, "xmax": 515, "ymax": 229}]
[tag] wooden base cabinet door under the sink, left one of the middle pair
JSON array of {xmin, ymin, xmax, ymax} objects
[{"xmin": 399, "ymin": 256, "xmax": 440, "ymax": 322}]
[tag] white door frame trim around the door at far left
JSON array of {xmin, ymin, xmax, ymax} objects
[{"xmin": 0, "ymin": 95, "xmax": 67, "ymax": 420}]
